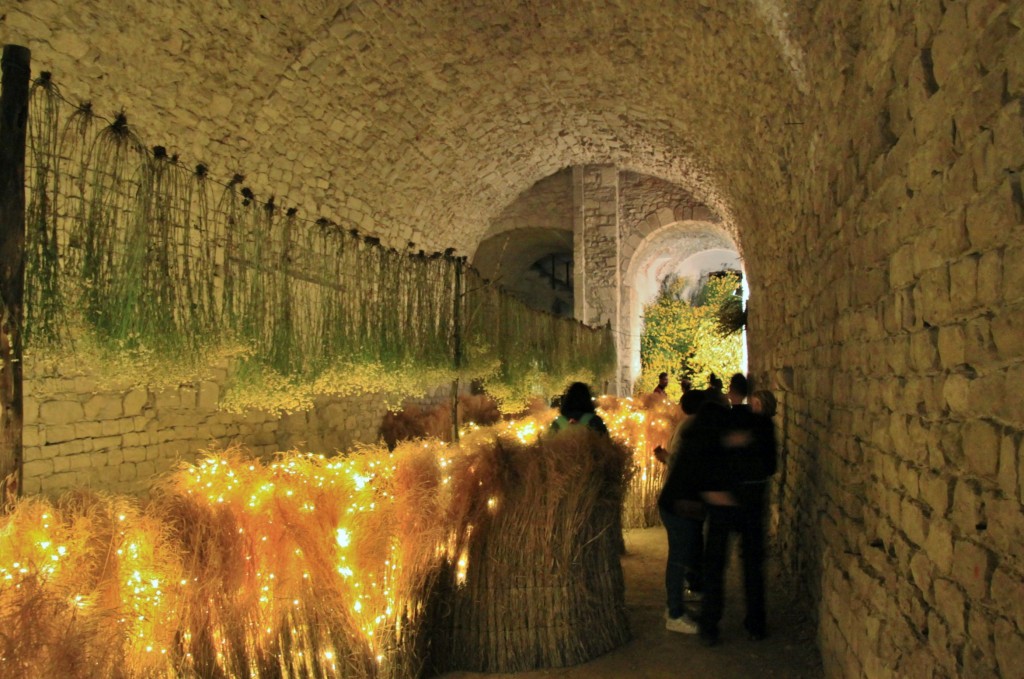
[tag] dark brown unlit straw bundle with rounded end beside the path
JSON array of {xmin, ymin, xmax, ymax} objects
[{"xmin": 433, "ymin": 430, "xmax": 630, "ymax": 672}]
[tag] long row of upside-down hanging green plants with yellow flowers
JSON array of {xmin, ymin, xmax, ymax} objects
[{"xmin": 26, "ymin": 76, "xmax": 614, "ymax": 410}]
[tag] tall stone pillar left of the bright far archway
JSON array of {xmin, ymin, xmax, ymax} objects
[{"xmin": 572, "ymin": 165, "xmax": 621, "ymax": 392}]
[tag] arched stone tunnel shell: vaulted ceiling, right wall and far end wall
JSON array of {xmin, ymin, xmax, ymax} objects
[{"xmin": 0, "ymin": 0, "xmax": 1024, "ymax": 677}]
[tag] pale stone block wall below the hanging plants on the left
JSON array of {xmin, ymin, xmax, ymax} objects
[{"xmin": 23, "ymin": 360, "xmax": 395, "ymax": 495}]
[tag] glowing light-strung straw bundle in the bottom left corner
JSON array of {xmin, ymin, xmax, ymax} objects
[{"xmin": 0, "ymin": 494, "xmax": 180, "ymax": 678}]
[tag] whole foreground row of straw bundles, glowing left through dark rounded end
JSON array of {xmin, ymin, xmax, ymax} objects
[{"xmin": 0, "ymin": 411, "xmax": 643, "ymax": 678}]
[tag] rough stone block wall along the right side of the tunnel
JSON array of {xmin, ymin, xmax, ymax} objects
[{"xmin": 739, "ymin": 0, "xmax": 1024, "ymax": 678}]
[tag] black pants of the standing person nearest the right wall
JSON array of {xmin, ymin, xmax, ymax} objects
[{"xmin": 699, "ymin": 483, "xmax": 766, "ymax": 639}]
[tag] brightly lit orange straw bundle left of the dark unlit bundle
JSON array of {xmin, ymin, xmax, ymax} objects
[{"xmin": 149, "ymin": 445, "xmax": 454, "ymax": 677}]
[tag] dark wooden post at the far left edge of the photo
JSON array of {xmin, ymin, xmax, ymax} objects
[{"xmin": 0, "ymin": 45, "xmax": 31, "ymax": 509}]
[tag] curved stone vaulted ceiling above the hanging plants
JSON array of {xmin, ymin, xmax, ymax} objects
[{"xmin": 0, "ymin": 0, "xmax": 803, "ymax": 260}]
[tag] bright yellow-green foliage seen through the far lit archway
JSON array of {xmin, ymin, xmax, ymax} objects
[{"xmin": 636, "ymin": 273, "xmax": 743, "ymax": 398}]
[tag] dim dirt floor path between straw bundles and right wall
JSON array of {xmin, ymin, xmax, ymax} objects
[{"xmin": 443, "ymin": 527, "xmax": 824, "ymax": 679}]
